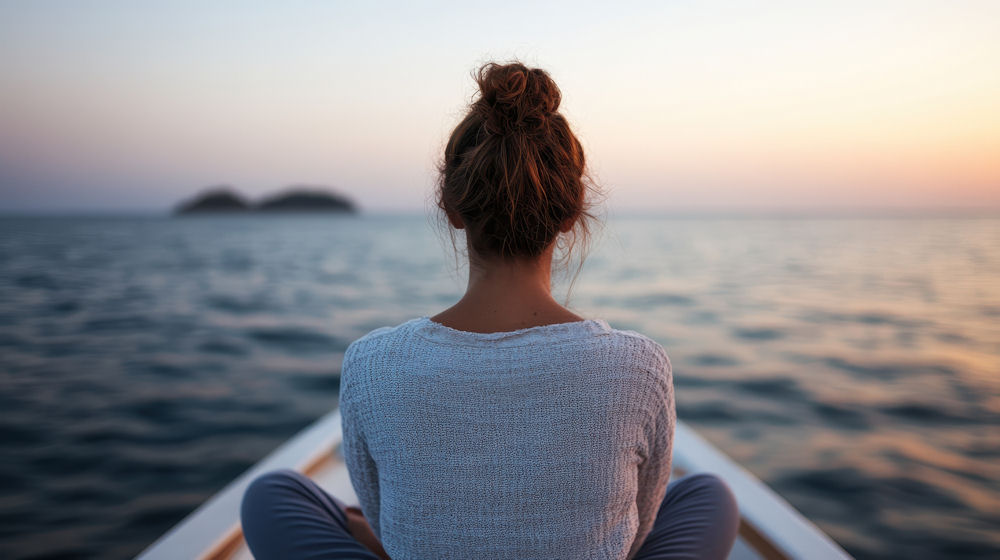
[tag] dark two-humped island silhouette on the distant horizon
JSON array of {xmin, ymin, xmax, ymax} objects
[{"xmin": 174, "ymin": 185, "xmax": 358, "ymax": 214}]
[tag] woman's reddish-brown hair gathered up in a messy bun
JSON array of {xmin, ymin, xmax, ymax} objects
[{"xmin": 437, "ymin": 61, "xmax": 596, "ymax": 264}]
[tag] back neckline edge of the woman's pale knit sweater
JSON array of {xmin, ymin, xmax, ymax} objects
[{"xmin": 416, "ymin": 315, "xmax": 611, "ymax": 346}]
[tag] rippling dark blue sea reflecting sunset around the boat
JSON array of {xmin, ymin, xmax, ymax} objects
[{"xmin": 0, "ymin": 217, "xmax": 1000, "ymax": 558}]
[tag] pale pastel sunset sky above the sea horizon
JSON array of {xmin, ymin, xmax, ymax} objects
[{"xmin": 0, "ymin": 0, "xmax": 1000, "ymax": 212}]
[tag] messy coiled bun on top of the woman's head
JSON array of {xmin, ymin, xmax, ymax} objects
[{"xmin": 473, "ymin": 62, "xmax": 562, "ymax": 135}]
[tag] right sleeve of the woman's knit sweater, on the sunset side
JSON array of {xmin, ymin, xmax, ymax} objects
[{"xmin": 628, "ymin": 349, "xmax": 677, "ymax": 558}]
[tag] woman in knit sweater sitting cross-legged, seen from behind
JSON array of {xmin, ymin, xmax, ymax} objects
[{"xmin": 242, "ymin": 63, "xmax": 739, "ymax": 560}]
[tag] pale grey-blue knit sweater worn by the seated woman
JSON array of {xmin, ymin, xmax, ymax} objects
[{"xmin": 340, "ymin": 317, "xmax": 676, "ymax": 560}]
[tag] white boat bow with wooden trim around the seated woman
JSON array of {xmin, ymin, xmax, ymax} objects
[{"xmin": 138, "ymin": 410, "xmax": 850, "ymax": 560}]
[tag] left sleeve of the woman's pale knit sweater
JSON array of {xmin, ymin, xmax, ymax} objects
[{"xmin": 340, "ymin": 352, "xmax": 382, "ymax": 540}]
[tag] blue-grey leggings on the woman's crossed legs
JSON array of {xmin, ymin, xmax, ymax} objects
[{"xmin": 240, "ymin": 470, "xmax": 740, "ymax": 560}]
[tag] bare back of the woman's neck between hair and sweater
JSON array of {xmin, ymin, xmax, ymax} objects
[{"xmin": 432, "ymin": 248, "xmax": 583, "ymax": 332}]
